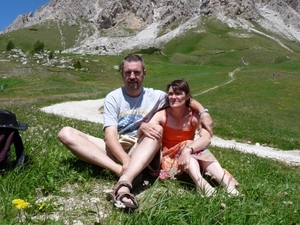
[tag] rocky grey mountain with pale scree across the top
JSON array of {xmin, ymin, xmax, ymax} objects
[{"xmin": 1, "ymin": 0, "xmax": 300, "ymax": 54}]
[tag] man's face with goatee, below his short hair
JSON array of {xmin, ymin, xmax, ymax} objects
[{"xmin": 122, "ymin": 62, "xmax": 146, "ymax": 96}]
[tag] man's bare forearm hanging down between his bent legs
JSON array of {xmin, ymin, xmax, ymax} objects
[{"xmin": 105, "ymin": 126, "xmax": 130, "ymax": 172}]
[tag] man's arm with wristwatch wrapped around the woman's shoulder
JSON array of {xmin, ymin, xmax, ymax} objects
[{"xmin": 190, "ymin": 98, "xmax": 213, "ymax": 136}]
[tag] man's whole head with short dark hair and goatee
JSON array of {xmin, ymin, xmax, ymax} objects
[{"xmin": 121, "ymin": 55, "xmax": 146, "ymax": 97}]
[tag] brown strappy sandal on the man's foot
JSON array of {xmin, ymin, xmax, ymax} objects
[{"xmin": 107, "ymin": 181, "xmax": 138, "ymax": 210}]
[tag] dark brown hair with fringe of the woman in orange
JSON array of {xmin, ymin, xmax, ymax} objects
[{"xmin": 166, "ymin": 80, "xmax": 191, "ymax": 107}]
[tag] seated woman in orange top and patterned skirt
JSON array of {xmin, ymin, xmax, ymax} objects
[{"xmin": 141, "ymin": 80, "xmax": 239, "ymax": 196}]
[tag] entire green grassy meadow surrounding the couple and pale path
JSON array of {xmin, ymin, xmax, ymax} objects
[{"xmin": 0, "ymin": 16, "xmax": 300, "ymax": 225}]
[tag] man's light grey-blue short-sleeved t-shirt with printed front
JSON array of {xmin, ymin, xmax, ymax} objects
[{"xmin": 103, "ymin": 87, "xmax": 167, "ymax": 136}]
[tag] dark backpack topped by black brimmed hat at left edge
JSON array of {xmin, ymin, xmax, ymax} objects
[{"xmin": 0, "ymin": 109, "xmax": 28, "ymax": 173}]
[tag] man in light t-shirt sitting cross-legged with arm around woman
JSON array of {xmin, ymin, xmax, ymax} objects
[{"xmin": 58, "ymin": 55, "xmax": 212, "ymax": 206}]
